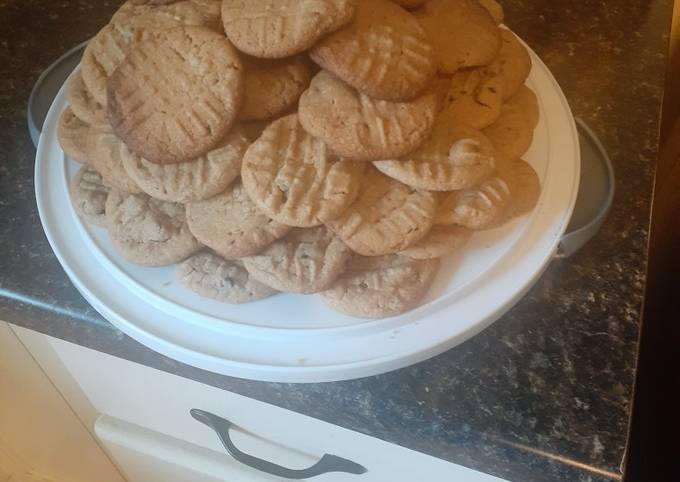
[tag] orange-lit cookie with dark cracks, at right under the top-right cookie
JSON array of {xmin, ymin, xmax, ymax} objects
[{"xmin": 443, "ymin": 69, "xmax": 505, "ymax": 130}]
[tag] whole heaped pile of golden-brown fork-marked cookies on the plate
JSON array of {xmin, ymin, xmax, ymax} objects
[{"xmin": 59, "ymin": 0, "xmax": 540, "ymax": 318}]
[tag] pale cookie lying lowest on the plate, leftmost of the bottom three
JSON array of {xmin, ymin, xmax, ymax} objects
[{"xmin": 175, "ymin": 252, "xmax": 276, "ymax": 304}]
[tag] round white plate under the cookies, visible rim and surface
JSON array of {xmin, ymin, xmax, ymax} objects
[{"xmin": 35, "ymin": 38, "xmax": 580, "ymax": 382}]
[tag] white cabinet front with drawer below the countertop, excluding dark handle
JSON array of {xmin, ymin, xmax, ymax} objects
[{"xmin": 11, "ymin": 329, "xmax": 510, "ymax": 482}]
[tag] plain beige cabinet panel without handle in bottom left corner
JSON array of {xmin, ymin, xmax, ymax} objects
[{"xmin": 0, "ymin": 321, "xmax": 123, "ymax": 482}]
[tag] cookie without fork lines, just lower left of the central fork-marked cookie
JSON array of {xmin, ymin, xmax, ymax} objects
[{"xmin": 187, "ymin": 183, "xmax": 291, "ymax": 258}]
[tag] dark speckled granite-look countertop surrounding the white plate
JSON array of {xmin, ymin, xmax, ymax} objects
[{"xmin": 0, "ymin": 0, "xmax": 673, "ymax": 482}]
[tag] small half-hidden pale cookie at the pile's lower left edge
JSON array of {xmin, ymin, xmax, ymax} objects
[{"xmin": 69, "ymin": 166, "xmax": 110, "ymax": 227}]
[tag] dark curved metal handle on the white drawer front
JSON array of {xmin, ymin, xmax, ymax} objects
[{"xmin": 189, "ymin": 408, "xmax": 366, "ymax": 480}]
